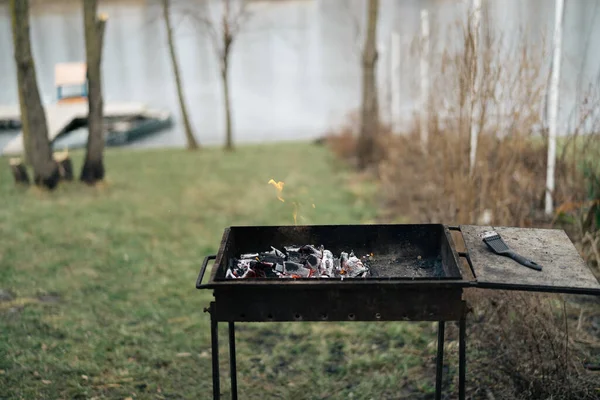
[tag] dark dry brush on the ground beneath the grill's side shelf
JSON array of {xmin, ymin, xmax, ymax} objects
[{"xmin": 467, "ymin": 290, "xmax": 600, "ymax": 400}]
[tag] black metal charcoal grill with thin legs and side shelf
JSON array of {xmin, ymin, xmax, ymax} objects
[{"xmin": 196, "ymin": 224, "xmax": 600, "ymax": 399}]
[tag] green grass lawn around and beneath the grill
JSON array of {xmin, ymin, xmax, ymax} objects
[{"xmin": 0, "ymin": 143, "xmax": 442, "ymax": 399}]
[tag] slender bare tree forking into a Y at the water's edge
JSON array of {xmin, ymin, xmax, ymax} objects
[{"xmin": 189, "ymin": 0, "xmax": 249, "ymax": 150}]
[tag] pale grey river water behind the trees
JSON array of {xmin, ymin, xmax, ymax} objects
[{"xmin": 0, "ymin": 0, "xmax": 600, "ymax": 150}]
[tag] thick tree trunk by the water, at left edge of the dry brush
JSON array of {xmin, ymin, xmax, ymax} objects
[{"xmin": 357, "ymin": 0, "xmax": 379, "ymax": 169}]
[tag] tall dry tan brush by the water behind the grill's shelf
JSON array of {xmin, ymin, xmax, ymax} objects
[{"xmin": 378, "ymin": 2, "xmax": 600, "ymax": 231}]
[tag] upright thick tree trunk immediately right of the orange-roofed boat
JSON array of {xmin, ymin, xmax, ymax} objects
[{"xmin": 80, "ymin": 0, "xmax": 106, "ymax": 185}]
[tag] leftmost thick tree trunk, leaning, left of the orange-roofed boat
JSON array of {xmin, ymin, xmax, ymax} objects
[{"xmin": 10, "ymin": 0, "xmax": 59, "ymax": 189}]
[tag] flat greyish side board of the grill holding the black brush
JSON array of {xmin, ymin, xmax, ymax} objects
[{"xmin": 460, "ymin": 225, "xmax": 600, "ymax": 295}]
